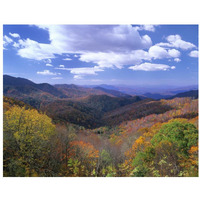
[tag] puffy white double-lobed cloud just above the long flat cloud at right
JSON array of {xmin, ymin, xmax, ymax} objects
[{"xmin": 149, "ymin": 45, "xmax": 181, "ymax": 59}]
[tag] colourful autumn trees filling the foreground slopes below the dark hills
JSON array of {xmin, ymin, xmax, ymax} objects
[{"xmin": 3, "ymin": 98, "xmax": 198, "ymax": 177}]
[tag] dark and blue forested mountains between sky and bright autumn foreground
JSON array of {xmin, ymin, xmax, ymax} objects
[{"xmin": 3, "ymin": 75, "xmax": 198, "ymax": 128}]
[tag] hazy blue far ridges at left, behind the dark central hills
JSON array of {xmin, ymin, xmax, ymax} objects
[{"xmin": 3, "ymin": 75, "xmax": 141, "ymax": 108}]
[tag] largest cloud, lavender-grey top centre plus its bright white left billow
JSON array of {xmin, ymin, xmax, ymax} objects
[{"xmin": 12, "ymin": 25, "xmax": 152, "ymax": 60}]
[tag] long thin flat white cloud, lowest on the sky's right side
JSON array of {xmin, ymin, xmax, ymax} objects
[{"xmin": 129, "ymin": 63, "xmax": 174, "ymax": 71}]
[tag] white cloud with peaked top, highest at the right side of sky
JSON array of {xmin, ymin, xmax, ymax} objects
[{"xmin": 156, "ymin": 35, "xmax": 196, "ymax": 50}]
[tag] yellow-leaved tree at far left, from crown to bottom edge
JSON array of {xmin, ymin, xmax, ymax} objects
[{"xmin": 3, "ymin": 106, "xmax": 55, "ymax": 176}]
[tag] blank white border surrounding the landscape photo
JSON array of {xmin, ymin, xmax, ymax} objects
[{"xmin": 0, "ymin": 0, "xmax": 200, "ymax": 200}]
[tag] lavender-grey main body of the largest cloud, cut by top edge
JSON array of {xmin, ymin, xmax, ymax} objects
[{"xmin": 39, "ymin": 25, "xmax": 152, "ymax": 53}]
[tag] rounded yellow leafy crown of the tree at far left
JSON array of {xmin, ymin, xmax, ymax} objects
[{"xmin": 3, "ymin": 106, "xmax": 55, "ymax": 141}]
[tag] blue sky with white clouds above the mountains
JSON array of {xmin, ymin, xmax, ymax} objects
[{"xmin": 3, "ymin": 25, "xmax": 199, "ymax": 86}]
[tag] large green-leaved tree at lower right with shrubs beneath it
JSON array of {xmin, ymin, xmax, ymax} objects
[{"xmin": 132, "ymin": 119, "xmax": 198, "ymax": 176}]
